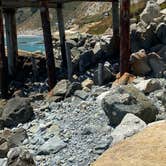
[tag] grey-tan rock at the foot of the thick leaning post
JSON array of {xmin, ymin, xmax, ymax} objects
[{"xmin": 51, "ymin": 80, "xmax": 70, "ymax": 96}]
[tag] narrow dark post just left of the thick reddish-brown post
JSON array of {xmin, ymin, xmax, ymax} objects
[{"xmin": 112, "ymin": 0, "xmax": 120, "ymax": 60}]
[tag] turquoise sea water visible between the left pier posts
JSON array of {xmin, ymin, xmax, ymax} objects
[{"xmin": 5, "ymin": 35, "xmax": 45, "ymax": 53}]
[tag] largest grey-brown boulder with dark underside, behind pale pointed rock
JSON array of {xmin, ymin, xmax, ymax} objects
[{"xmin": 102, "ymin": 85, "xmax": 158, "ymax": 126}]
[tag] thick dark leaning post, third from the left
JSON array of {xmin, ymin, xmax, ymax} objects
[{"xmin": 40, "ymin": 0, "xmax": 56, "ymax": 90}]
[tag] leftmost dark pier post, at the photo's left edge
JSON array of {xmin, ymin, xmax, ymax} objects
[{"xmin": 0, "ymin": 0, "xmax": 8, "ymax": 98}]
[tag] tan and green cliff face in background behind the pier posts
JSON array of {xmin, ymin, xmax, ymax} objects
[{"xmin": 17, "ymin": 0, "xmax": 165, "ymax": 34}]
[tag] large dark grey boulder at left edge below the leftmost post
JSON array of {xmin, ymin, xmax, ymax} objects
[{"xmin": 0, "ymin": 97, "xmax": 34, "ymax": 129}]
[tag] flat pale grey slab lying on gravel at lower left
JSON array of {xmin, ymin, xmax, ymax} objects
[{"xmin": 38, "ymin": 136, "xmax": 66, "ymax": 155}]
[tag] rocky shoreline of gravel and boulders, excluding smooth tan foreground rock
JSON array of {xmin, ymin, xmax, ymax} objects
[{"xmin": 0, "ymin": 1, "xmax": 166, "ymax": 166}]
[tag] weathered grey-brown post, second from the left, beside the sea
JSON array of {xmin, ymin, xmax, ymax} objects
[{"xmin": 3, "ymin": 9, "xmax": 18, "ymax": 78}]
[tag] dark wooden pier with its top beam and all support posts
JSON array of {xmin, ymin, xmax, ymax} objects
[{"xmin": 0, "ymin": 0, "xmax": 130, "ymax": 98}]
